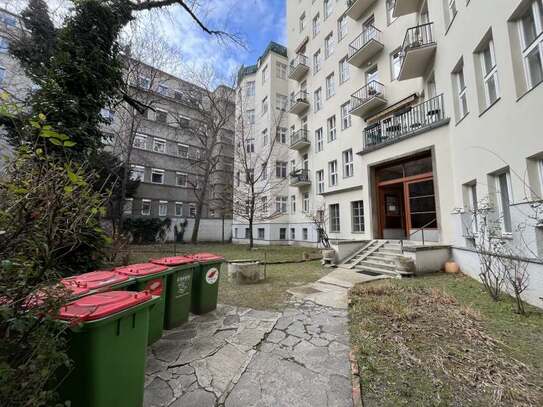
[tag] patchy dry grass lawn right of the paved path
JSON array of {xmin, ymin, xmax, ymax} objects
[{"xmin": 350, "ymin": 273, "xmax": 543, "ymax": 406}]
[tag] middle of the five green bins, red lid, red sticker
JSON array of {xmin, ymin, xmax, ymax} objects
[{"xmin": 113, "ymin": 263, "xmax": 171, "ymax": 345}]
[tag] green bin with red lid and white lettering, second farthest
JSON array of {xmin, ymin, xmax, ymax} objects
[{"xmin": 151, "ymin": 256, "xmax": 198, "ymax": 329}]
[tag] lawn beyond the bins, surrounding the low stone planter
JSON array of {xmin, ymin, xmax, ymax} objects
[{"xmin": 130, "ymin": 244, "xmax": 328, "ymax": 309}]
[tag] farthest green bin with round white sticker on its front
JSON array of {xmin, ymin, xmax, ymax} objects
[{"xmin": 190, "ymin": 253, "xmax": 224, "ymax": 315}]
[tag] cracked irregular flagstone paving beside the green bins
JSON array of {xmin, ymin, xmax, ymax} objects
[{"xmin": 144, "ymin": 300, "xmax": 352, "ymax": 407}]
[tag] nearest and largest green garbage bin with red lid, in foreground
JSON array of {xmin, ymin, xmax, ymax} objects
[{"xmin": 59, "ymin": 291, "xmax": 159, "ymax": 407}]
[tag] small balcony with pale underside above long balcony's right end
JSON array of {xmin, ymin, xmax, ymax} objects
[{"xmin": 398, "ymin": 23, "xmax": 437, "ymax": 81}]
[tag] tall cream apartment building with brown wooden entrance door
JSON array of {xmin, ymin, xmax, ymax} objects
[{"xmin": 234, "ymin": 0, "xmax": 543, "ymax": 302}]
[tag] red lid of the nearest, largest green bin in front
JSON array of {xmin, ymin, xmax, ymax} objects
[{"xmin": 59, "ymin": 291, "xmax": 153, "ymax": 321}]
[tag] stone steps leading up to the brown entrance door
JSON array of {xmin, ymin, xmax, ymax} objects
[{"xmin": 338, "ymin": 240, "xmax": 414, "ymax": 277}]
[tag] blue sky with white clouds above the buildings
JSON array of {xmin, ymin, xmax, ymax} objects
[{"xmin": 0, "ymin": 0, "xmax": 286, "ymax": 81}]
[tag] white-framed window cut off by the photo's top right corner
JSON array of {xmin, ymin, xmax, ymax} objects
[{"xmin": 520, "ymin": 0, "xmax": 543, "ymax": 89}]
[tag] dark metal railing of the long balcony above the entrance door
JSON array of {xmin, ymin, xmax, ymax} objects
[{"xmin": 364, "ymin": 95, "xmax": 445, "ymax": 149}]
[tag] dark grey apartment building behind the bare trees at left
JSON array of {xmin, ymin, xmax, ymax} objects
[{"xmin": 0, "ymin": 10, "xmax": 234, "ymax": 241}]
